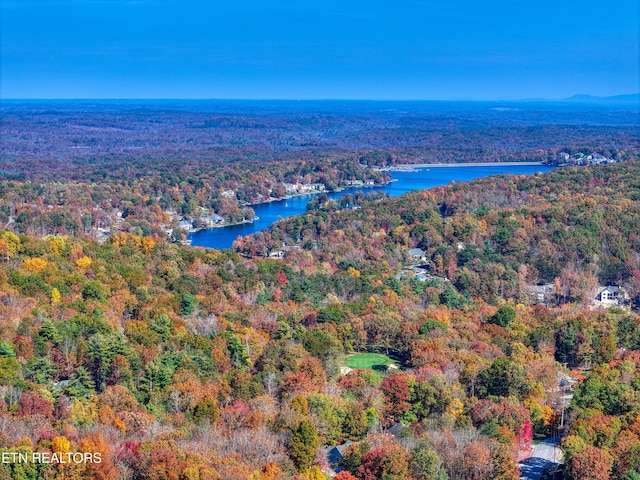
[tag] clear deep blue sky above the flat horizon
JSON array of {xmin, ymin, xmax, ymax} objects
[{"xmin": 0, "ymin": 0, "xmax": 640, "ymax": 100}]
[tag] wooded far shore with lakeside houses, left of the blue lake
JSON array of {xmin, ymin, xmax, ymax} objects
[{"xmin": 0, "ymin": 156, "xmax": 388, "ymax": 240}]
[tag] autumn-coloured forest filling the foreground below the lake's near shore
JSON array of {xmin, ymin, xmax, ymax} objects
[{"xmin": 0, "ymin": 162, "xmax": 640, "ymax": 480}]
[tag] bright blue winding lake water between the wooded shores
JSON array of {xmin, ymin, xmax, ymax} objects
[{"xmin": 187, "ymin": 165, "xmax": 553, "ymax": 249}]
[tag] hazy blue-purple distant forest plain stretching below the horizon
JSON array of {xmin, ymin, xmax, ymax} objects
[{"xmin": 0, "ymin": 102, "xmax": 640, "ymax": 182}]
